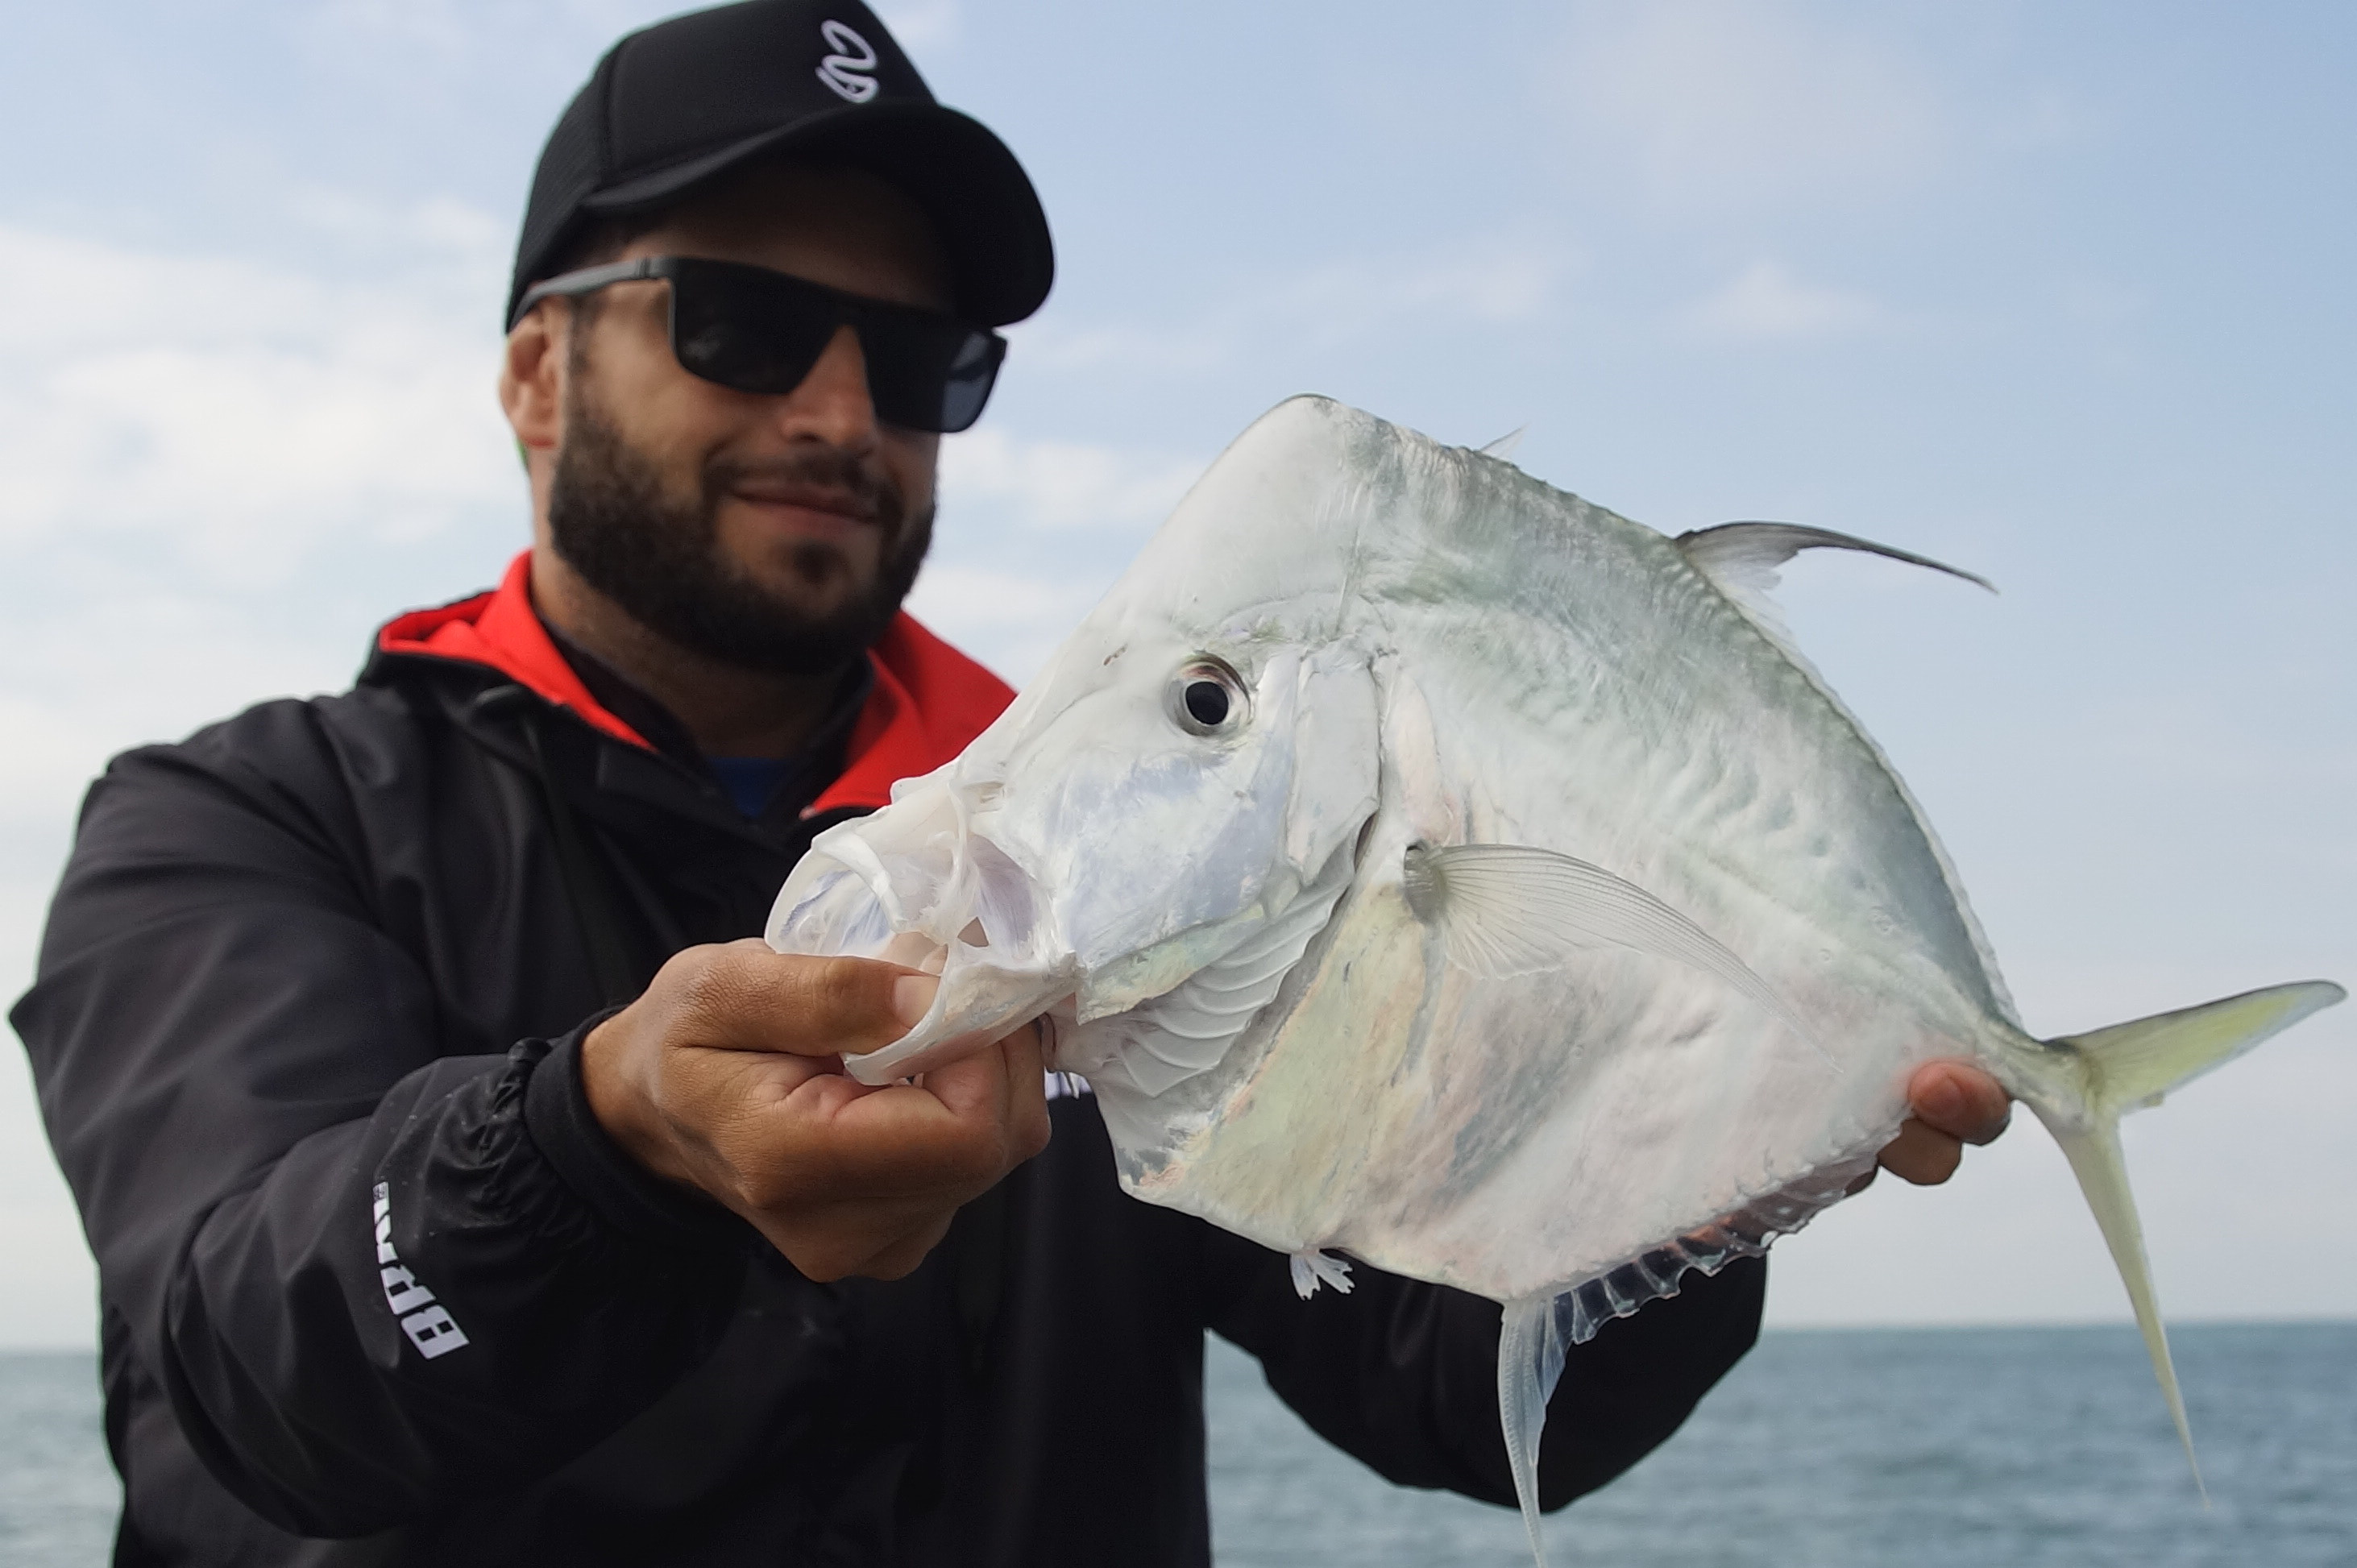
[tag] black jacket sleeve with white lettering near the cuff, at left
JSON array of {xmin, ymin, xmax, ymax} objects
[{"xmin": 12, "ymin": 721, "xmax": 752, "ymax": 1535}]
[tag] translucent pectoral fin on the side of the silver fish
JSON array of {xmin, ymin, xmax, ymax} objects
[{"xmin": 1402, "ymin": 844, "xmax": 1832, "ymax": 1061}]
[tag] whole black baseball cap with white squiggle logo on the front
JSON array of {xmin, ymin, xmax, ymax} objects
[{"xmin": 502, "ymin": 0, "xmax": 1056, "ymax": 328}]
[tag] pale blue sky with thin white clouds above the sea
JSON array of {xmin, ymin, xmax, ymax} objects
[{"xmin": 0, "ymin": 0, "xmax": 2357, "ymax": 1344}]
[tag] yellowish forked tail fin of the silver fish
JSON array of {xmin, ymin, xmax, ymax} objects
[{"xmin": 2034, "ymin": 981, "xmax": 2347, "ymax": 1500}]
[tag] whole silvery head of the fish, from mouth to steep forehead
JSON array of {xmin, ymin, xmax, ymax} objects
[{"xmin": 769, "ymin": 403, "xmax": 1379, "ymax": 1082}]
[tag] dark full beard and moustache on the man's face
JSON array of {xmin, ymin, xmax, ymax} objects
[{"xmin": 550, "ymin": 375, "xmax": 933, "ymax": 674}]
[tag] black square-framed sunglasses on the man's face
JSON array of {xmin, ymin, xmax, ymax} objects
[{"xmin": 509, "ymin": 257, "xmax": 1006, "ymax": 436}]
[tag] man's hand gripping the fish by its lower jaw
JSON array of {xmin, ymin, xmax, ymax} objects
[{"xmin": 582, "ymin": 941, "xmax": 1049, "ymax": 1280}]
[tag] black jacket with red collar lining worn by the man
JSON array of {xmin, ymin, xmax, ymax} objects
[{"xmin": 15, "ymin": 575, "xmax": 1763, "ymax": 1568}]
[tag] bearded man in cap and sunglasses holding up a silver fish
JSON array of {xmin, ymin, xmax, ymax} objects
[{"xmin": 15, "ymin": 0, "xmax": 2003, "ymax": 1563}]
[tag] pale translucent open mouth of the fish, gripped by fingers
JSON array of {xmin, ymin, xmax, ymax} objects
[{"xmin": 769, "ymin": 764, "xmax": 1073, "ymax": 1085}]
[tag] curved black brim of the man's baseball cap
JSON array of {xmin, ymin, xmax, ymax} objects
[{"xmin": 580, "ymin": 102, "xmax": 1056, "ymax": 328}]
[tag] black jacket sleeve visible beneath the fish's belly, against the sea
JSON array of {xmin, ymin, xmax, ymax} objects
[{"xmin": 1205, "ymin": 1233, "xmax": 1768, "ymax": 1509}]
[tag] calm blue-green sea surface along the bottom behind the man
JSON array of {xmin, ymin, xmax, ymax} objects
[{"xmin": 0, "ymin": 1323, "xmax": 2357, "ymax": 1568}]
